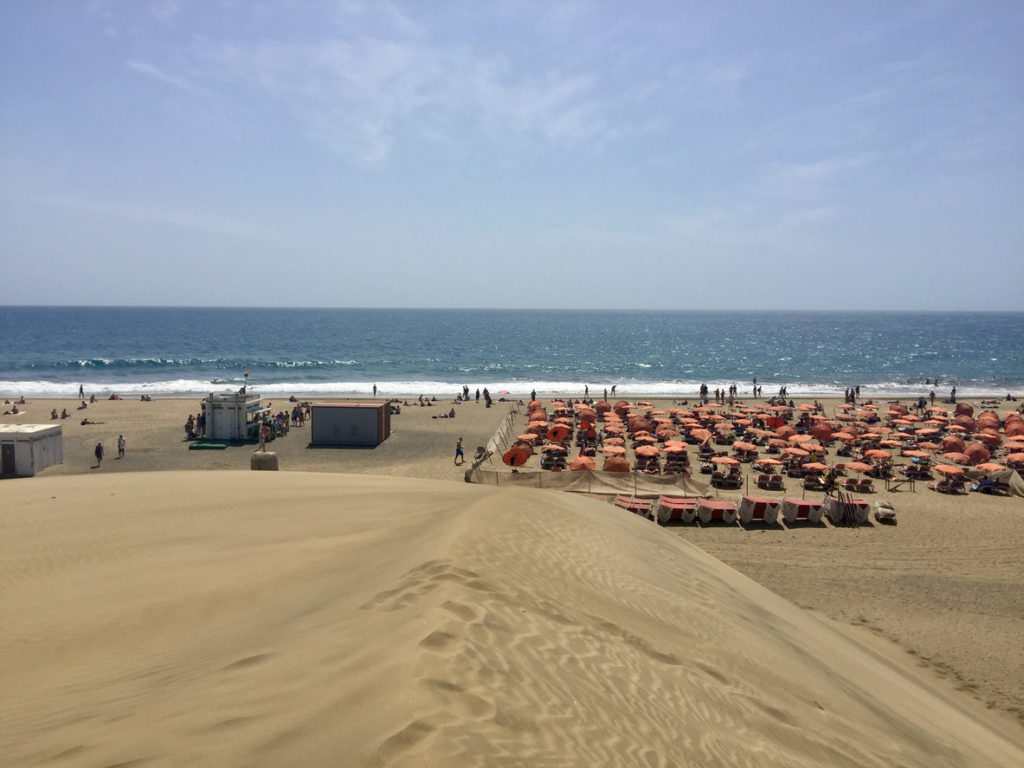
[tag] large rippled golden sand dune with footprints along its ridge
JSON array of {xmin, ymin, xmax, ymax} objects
[{"xmin": 0, "ymin": 471, "xmax": 1024, "ymax": 766}]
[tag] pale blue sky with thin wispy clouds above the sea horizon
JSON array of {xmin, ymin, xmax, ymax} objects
[{"xmin": 0, "ymin": 0, "xmax": 1024, "ymax": 311}]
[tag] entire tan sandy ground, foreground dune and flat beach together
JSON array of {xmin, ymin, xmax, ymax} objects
[{"xmin": 0, "ymin": 399, "xmax": 1024, "ymax": 766}]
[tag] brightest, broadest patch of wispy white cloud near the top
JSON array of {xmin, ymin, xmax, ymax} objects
[{"xmin": 190, "ymin": 30, "xmax": 638, "ymax": 163}]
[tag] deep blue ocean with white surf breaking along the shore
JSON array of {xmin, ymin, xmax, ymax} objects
[{"xmin": 0, "ymin": 307, "xmax": 1024, "ymax": 398}]
